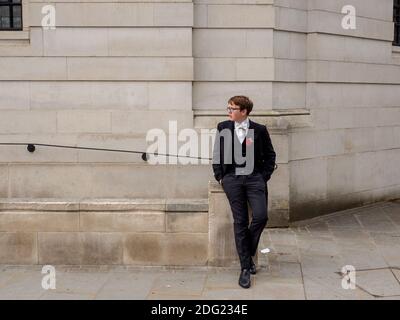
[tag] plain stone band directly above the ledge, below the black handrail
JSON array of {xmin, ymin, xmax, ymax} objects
[{"xmin": 9, "ymin": 166, "xmax": 211, "ymax": 199}]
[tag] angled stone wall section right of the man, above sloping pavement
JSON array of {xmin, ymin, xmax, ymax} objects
[{"xmin": 284, "ymin": 0, "xmax": 400, "ymax": 220}]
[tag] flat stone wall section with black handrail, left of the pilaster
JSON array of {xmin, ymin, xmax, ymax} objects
[{"xmin": 0, "ymin": 0, "xmax": 211, "ymax": 198}]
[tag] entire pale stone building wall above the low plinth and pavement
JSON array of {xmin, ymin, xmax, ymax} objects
[{"xmin": 0, "ymin": 0, "xmax": 400, "ymax": 225}]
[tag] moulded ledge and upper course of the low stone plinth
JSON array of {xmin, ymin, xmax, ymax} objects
[{"xmin": 0, "ymin": 199, "xmax": 208, "ymax": 233}]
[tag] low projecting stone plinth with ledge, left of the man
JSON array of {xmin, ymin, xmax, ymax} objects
[{"xmin": 0, "ymin": 199, "xmax": 208, "ymax": 266}]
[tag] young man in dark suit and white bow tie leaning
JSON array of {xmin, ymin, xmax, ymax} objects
[{"xmin": 213, "ymin": 96, "xmax": 276, "ymax": 288}]
